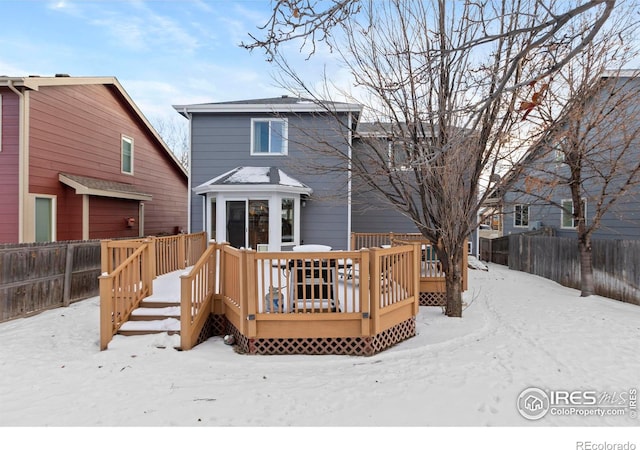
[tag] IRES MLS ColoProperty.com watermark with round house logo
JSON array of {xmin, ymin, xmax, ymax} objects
[{"xmin": 517, "ymin": 387, "xmax": 638, "ymax": 420}]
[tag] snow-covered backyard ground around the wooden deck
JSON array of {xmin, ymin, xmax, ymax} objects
[{"xmin": 0, "ymin": 265, "xmax": 640, "ymax": 450}]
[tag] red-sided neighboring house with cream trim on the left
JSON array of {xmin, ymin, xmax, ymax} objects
[{"xmin": 0, "ymin": 75, "xmax": 188, "ymax": 243}]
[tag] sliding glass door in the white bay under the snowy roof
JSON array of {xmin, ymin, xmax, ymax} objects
[{"xmin": 227, "ymin": 200, "xmax": 269, "ymax": 250}]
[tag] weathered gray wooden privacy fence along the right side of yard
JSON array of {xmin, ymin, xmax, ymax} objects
[{"xmin": 481, "ymin": 234, "xmax": 640, "ymax": 305}]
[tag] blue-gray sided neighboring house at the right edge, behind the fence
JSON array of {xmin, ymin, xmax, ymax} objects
[{"xmin": 495, "ymin": 71, "xmax": 640, "ymax": 239}]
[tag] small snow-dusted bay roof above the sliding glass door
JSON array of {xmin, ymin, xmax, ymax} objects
[{"xmin": 193, "ymin": 167, "xmax": 313, "ymax": 195}]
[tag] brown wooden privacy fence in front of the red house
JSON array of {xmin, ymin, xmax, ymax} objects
[{"xmin": 0, "ymin": 240, "xmax": 100, "ymax": 322}]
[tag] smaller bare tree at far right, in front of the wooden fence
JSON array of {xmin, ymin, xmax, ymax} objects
[{"xmin": 510, "ymin": 7, "xmax": 640, "ymax": 297}]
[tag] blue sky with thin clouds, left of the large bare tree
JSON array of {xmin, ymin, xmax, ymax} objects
[{"xmin": 0, "ymin": 0, "xmax": 344, "ymax": 122}]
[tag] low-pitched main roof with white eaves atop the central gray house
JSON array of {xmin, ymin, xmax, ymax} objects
[{"xmin": 173, "ymin": 95, "xmax": 362, "ymax": 118}]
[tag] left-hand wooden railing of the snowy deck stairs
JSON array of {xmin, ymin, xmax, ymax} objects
[{"xmin": 100, "ymin": 239, "xmax": 153, "ymax": 350}]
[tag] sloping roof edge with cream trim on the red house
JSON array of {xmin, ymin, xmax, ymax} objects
[{"xmin": 0, "ymin": 74, "xmax": 188, "ymax": 178}]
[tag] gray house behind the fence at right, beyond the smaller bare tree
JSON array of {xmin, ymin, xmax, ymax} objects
[{"xmin": 500, "ymin": 71, "xmax": 640, "ymax": 239}]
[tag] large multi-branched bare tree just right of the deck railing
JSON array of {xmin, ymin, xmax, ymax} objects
[{"xmin": 245, "ymin": 0, "xmax": 615, "ymax": 317}]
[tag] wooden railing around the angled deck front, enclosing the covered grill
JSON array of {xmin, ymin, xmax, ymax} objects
[{"xmin": 181, "ymin": 244, "xmax": 419, "ymax": 342}]
